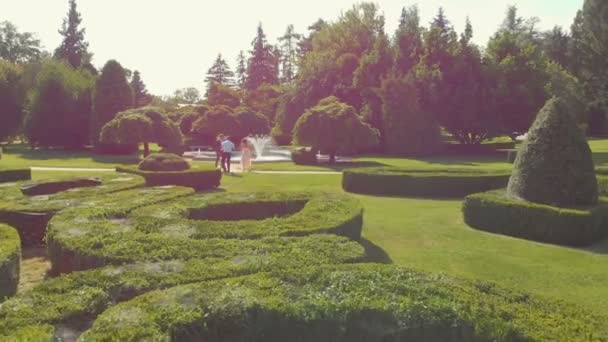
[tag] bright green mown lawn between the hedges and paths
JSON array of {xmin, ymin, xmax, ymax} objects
[{"xmin": 5, "ymin": 140, "xmax": 608, "ymax": 312}]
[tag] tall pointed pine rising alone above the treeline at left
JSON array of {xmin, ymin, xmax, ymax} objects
[{"xmin": 55, "ymin": 0, "xmax": 92, "ymax": 68}]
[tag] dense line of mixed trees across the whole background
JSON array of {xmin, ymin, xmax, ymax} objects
[{"xmin": 0, "ymin": 0, "xmax": 608, "ymax": 155}]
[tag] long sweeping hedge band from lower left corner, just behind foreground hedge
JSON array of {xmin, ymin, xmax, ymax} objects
[{"xmin": 0, "ymin": 235, "xmax": 365, "ymax": 341}]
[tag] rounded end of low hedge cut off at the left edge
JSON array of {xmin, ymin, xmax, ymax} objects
[{"xmin": 0, "ymin": 224, "xmax": 21, "ymax": 302}]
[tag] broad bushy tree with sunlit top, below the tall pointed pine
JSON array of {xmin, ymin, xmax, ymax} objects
[{"xmin": 24, "ymin": 60, "xmax": 94, "ymax": 148}]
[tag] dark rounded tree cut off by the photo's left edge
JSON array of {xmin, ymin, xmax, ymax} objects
[{"xmin": 0, "ymin": 60, "xmax": 25, "ymax": 141}]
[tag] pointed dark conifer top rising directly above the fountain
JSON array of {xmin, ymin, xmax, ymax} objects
[{"xmin": 246, "ymin": 24, "xmax": 279, "ymax": 90}]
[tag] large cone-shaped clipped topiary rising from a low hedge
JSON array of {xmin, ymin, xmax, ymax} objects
[{"xmin": 507, "ymin": 98, "xmax": 598, "ymax": 207}]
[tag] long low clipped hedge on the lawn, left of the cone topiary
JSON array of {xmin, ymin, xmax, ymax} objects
[{"xmin": 342, "ymin": 167, "xmax": 510, "ymax": 197}]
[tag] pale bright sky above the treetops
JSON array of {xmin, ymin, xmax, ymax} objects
[{"xmin": 5, "ymin": 0, "xmax": 583, "ymax": 95}]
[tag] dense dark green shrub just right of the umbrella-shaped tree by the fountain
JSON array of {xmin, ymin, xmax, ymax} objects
[{"xmin": 380, "ymin": 75, "xmax": 441, "ymax": 155}]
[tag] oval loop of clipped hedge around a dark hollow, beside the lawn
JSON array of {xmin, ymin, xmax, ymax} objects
[{"xmin": 129, "ymin": 192, "xmax": 363, "ymax": 241}]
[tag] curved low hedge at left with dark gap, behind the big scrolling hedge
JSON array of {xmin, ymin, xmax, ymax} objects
[{"xmin": 0, "ymin": 174, "xmax": 144, "ymax": 246}]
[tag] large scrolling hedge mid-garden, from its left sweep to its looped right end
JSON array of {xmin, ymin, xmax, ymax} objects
[{"xmin": 47, "ymin": 188, "xmax": 362, "ymax": 273}]
